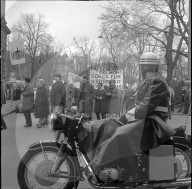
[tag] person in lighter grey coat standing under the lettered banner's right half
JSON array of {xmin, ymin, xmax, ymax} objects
[{"xmin": 106, "ymin": 80, "xmax": 121, "ymax": 118}]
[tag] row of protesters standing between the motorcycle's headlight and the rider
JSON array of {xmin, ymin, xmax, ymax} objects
[{"xmin": 50, "ymin": 74, "xmax": 136, "ymax": 120}]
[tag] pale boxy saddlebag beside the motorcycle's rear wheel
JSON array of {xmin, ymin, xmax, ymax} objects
[{"xmin": 149, "ymin": 145, "xmax": 176, "ymax": 181}]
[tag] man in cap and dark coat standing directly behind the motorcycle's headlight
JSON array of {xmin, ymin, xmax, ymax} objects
[{"xmin": 50, "ymin": 74, "xmax": 65, "ymax": 113}]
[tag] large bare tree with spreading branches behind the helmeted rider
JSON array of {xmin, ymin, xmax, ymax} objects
[{"xmin": 101, "ymin": 0, "xmax": 188, "ymax": 80}]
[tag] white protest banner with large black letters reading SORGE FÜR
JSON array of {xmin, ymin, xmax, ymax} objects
[{"xmin": 90, "ymin": 70, "xmax": 123, "ymax": 89}]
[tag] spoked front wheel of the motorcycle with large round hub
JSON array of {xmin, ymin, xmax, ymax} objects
[{"xmin": 17, "ymin": 147, "xmax": 79, "ymax": 189}]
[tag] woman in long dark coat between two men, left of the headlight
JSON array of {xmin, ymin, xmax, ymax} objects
[{"xmin": 35, "ymin": 79, "xmax": 49, "ymax": 128}]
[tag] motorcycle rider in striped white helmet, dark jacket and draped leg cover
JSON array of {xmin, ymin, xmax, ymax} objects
[{"xmin": 95, "ymin": 52, "xmax": 175, "ymax": 182}]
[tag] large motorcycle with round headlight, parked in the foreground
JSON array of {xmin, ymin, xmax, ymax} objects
[{"xmin": 17, "ymin": 110, "xmax": 191, "ymax": 189}]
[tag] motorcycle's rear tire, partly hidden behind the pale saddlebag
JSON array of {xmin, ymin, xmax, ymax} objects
[{"xmin": 175, "ymin": 144, "xmax": 191, "ymax": 178}]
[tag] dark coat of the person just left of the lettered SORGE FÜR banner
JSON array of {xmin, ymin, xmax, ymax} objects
[{"xmin": 78, "ymin": 83, "xmax": 94, "ymax": 113}]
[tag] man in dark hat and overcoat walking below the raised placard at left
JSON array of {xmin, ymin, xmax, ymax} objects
[{"xmin": 21, "ymin": 78, "xmax": 34, "ymax": 127}]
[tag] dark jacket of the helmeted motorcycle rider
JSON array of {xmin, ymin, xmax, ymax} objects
[{"xmin": 135, "ymin": 73, "xmax": 170, "ymax": 120}]
